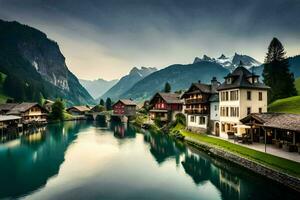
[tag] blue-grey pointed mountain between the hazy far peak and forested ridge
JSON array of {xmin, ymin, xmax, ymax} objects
[{"xmin": 101, "ymin": 67, "xmax": 157, "ymax": 100}]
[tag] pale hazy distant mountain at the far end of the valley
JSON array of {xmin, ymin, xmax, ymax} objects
[{"xmin": 79, "ymin": 78, "xmax": 118, "ymax": 99}]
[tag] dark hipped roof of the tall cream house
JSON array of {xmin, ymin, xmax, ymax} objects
[{"xmin": 218, "ymin": 66, "xmax": 270, "ymax": 90}]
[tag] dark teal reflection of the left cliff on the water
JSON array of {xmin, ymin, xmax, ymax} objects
[{"xmin": 0, "ymin": 122, "xmax": 86, "ymax": 198}]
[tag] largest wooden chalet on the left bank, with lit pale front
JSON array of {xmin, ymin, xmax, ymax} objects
[{"xmin": 7, "ymin": 102, "xmax": 48, "ymax": 124}]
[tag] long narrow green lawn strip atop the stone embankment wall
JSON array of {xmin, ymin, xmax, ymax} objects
[{"xmin": 173, "ymin": 125, "xmax": 300, "ymax": 178}]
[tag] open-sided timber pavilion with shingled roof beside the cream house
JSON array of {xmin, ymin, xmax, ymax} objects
[{"xmin": 240, "ymin": 113, "xmax": 300, "ymax": 153}]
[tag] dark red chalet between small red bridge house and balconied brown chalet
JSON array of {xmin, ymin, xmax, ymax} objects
[{"xmin": 150, "ymin": 92, "xmax": 183, "ymax": 122}]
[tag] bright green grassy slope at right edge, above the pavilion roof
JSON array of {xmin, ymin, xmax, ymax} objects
[{"xmin": 268, "ymin": 96, "xmax": 300, "ymax": 114}]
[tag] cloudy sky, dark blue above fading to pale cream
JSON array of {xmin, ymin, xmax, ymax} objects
[{"xmin": 0, "ymin": 0, "xmax": 300, "ymax": 80}]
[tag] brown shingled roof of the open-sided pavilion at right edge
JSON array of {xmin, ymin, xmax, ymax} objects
[{"xmin": 241, "ymin": 113, "xmax": 300, "ymax": 132}]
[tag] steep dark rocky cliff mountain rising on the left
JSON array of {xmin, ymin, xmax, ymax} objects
[{"xmin": 0, "ymin": 20, "xmax": 94, "ymax": 104}]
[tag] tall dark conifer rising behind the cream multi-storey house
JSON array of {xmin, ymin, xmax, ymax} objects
[{"xmin": 263, "ymin": 38, "xmax": 297, "ymax": 102}]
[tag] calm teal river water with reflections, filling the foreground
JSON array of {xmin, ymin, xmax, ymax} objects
[{"xmin": 0, "ymin": 122, "xmax": 299, "ymax": 200}]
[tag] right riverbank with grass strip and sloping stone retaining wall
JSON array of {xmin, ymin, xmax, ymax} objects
[{"xmin": 171, "ymin": 125, "xmax": 300, "ymax": 192}]
